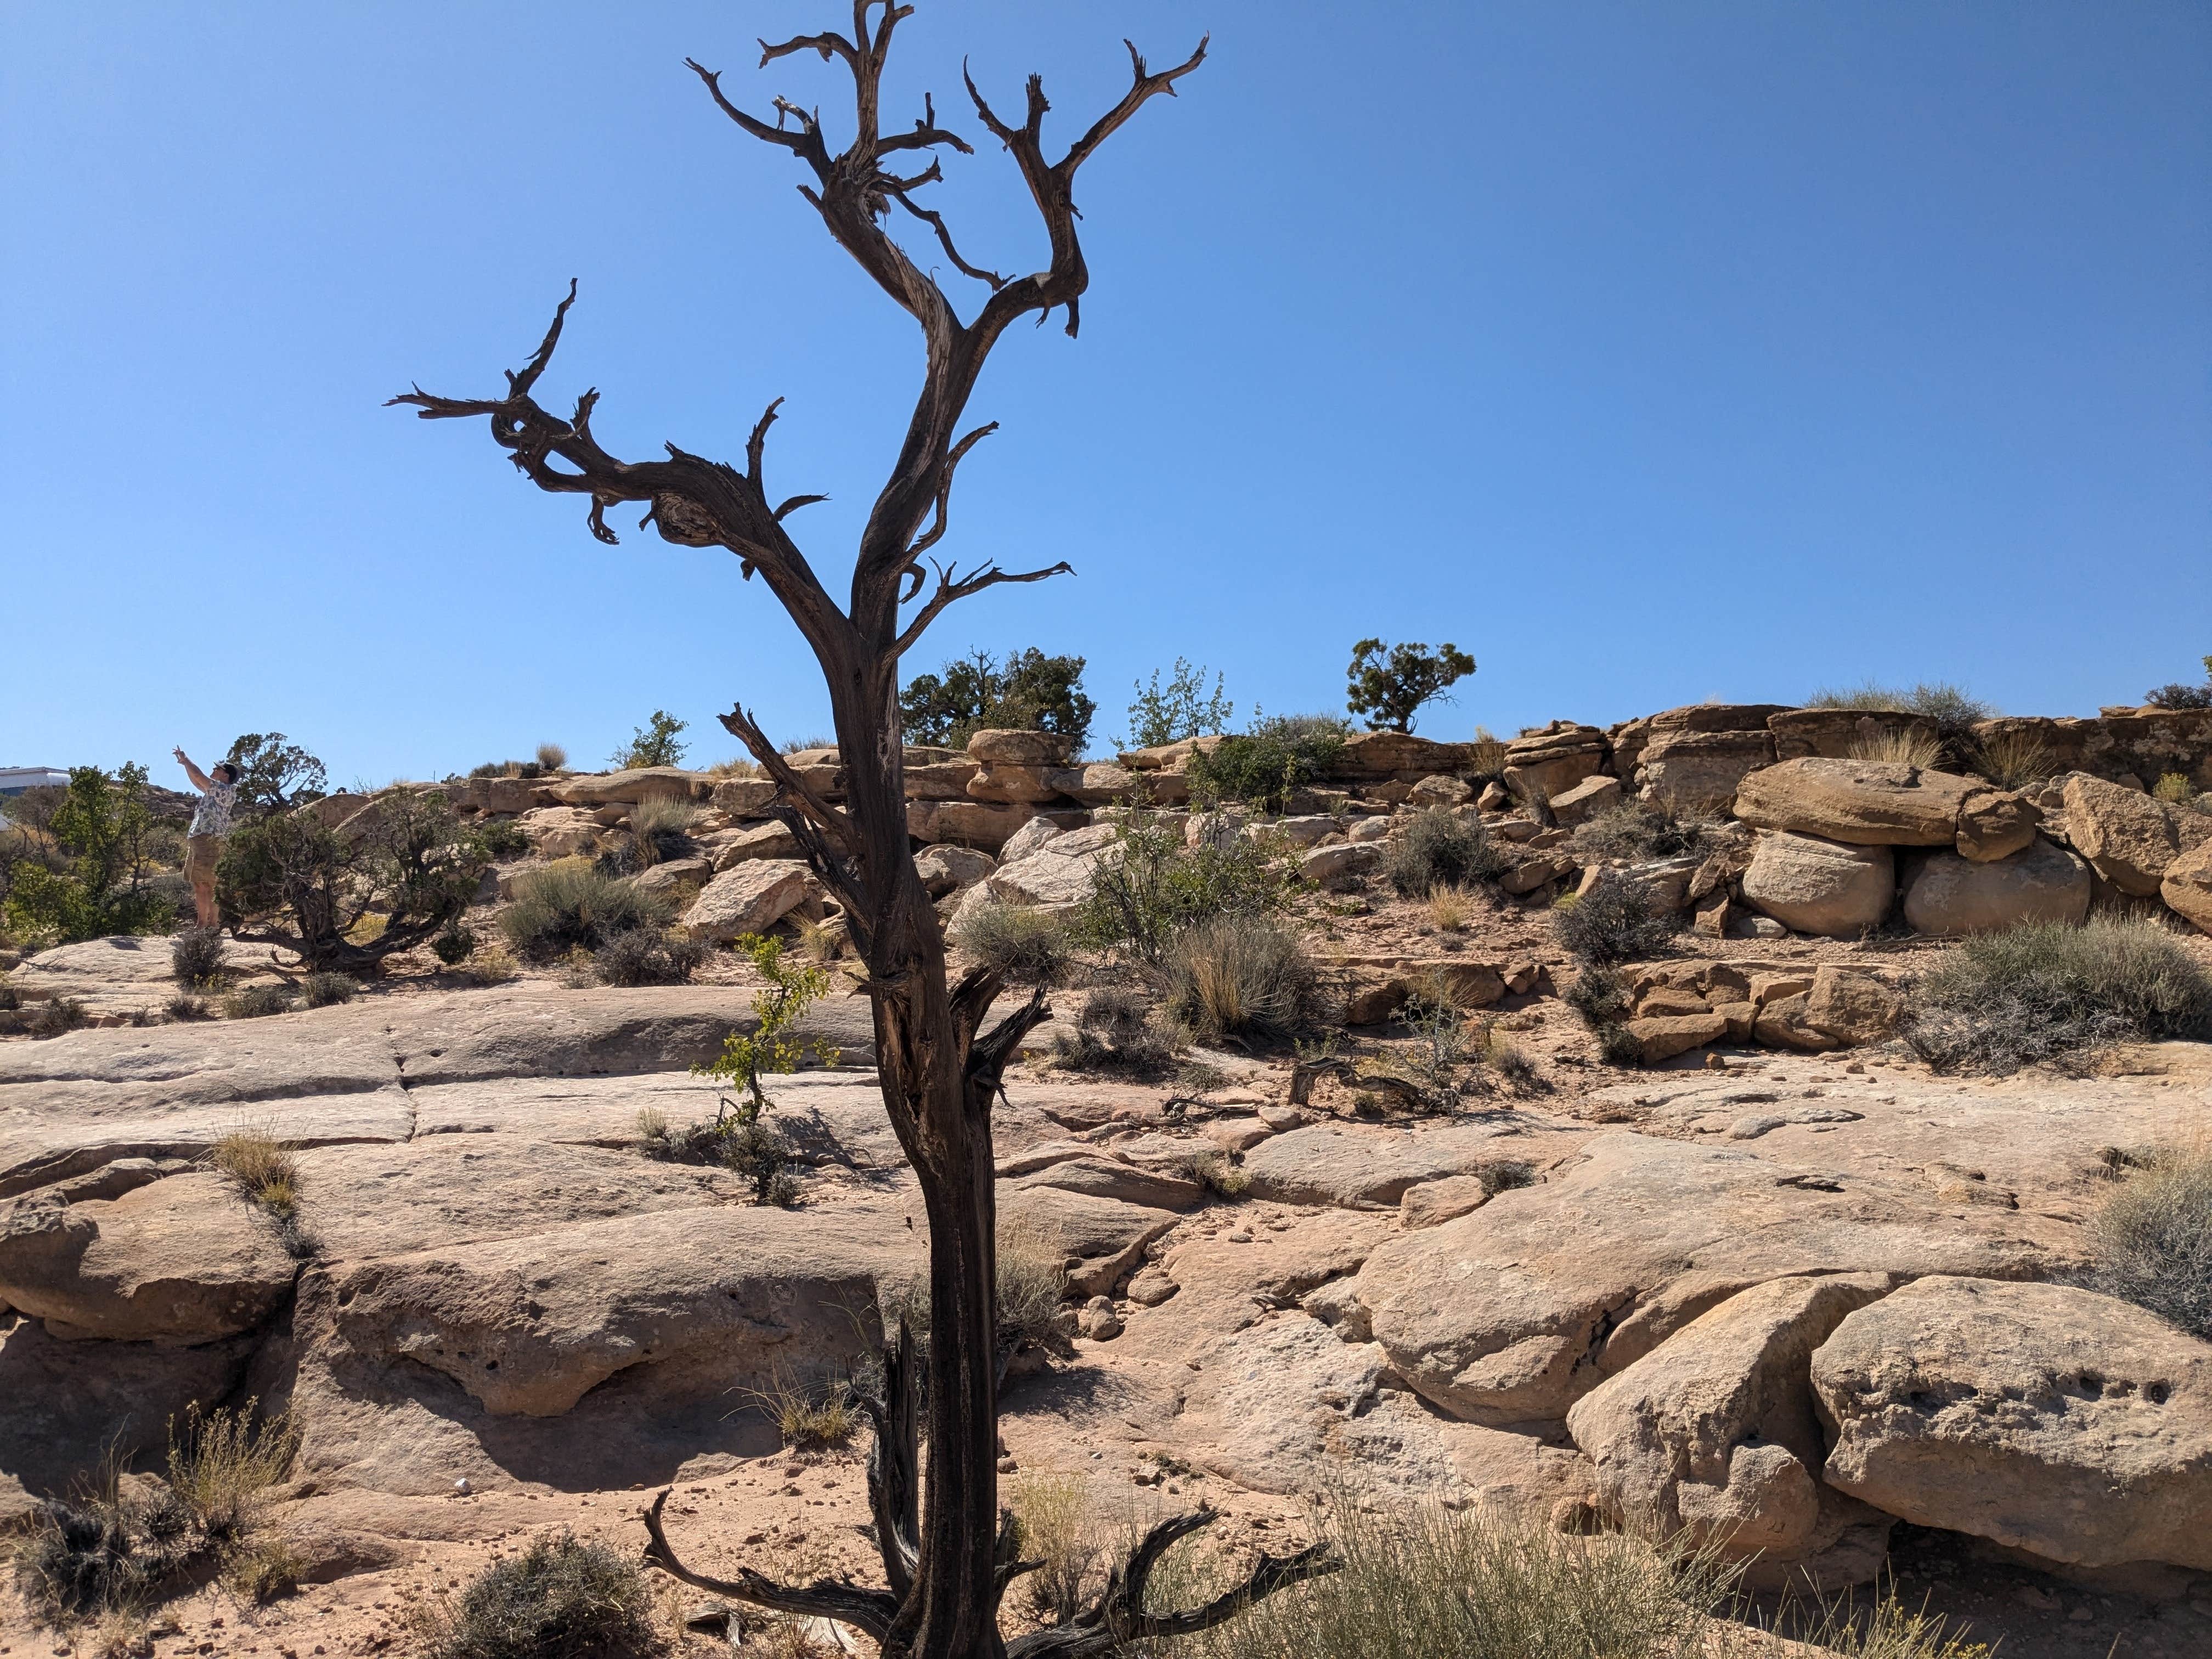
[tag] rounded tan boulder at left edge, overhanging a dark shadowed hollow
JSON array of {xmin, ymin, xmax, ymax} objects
[{"xmin": 0, "ymin": 1172, "xmax": 296, "ymax": 1342}]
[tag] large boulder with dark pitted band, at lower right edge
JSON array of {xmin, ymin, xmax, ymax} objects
[{"xmin": 1812, "ymin": 1276, "xmax": 2212, "ymax": 1568}]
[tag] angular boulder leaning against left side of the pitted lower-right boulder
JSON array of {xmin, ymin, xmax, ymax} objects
[{"xmin": 1566, "ymin": 1274, "xmax": 1895, "ymax": 1588}]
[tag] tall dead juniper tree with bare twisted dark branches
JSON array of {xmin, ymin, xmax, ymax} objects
[{"xmin": 394, "ymin": 0, "xmax": 1329, "ymax": 1659}]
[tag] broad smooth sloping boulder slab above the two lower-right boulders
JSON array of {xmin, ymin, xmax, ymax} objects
[{"xmin": 1353, "ymin": 1135, "xmax": 2046, "ymax": 1425}]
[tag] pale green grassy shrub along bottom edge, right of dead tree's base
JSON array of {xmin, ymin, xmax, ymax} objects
[{"xmin": 1177, "ymin": 1502, "xmax": 1730, "ymax": 1659}]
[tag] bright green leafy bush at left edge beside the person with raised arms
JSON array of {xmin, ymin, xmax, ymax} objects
[{"xmin": 0, "ymin": 763, "xmax": 175, "ymax": 945}]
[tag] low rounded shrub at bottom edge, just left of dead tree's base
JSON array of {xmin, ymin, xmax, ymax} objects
[{"xmin": 431, "ymin": 1533, "xmax": 659, "ymax": 1659}]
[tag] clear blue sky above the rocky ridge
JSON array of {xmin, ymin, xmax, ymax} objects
[{"xmin": 0, "ymin": 0, "xmax": 2212, "ymax": 783}]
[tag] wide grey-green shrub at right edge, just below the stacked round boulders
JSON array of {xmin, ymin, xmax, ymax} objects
[{"xmin": 1900, "ymin": 918, "xmax": 2212, "ymax": 1073}]
